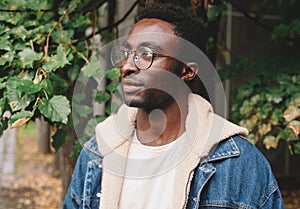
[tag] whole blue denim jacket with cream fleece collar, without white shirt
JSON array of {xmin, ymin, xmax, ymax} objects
[{"xmin": 64, "ymin": 94, "xmax": 283, "ymax": 209}]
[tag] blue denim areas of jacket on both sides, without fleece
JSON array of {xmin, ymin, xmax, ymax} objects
[{"xmin": 63, "ymin": 135, "xmax": 284, "ymax": 209}]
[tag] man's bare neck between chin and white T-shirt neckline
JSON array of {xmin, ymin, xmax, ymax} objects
[{"xmin": 136, "ymin": 101, "xmax": 188, "ymax": 146}]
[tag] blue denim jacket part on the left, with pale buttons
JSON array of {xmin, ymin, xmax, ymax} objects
[{"xmin": 63, "ymin": 137, "xmax": 102, "ymax": 209}]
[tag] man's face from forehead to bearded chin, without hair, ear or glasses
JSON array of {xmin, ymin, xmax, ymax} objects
[{"xmin": 121, "ymin": 19, "xmax": 183, "ymax": 111}]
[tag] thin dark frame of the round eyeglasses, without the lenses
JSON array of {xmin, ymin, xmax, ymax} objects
[{"xmin": 111, "ymin": 45, "xmax": 175, "ymax": 70}]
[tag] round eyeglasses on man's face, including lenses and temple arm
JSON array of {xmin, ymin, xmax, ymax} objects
[{"xmin": 111, "ymin": 46, "xmax": 170, "ymax": 70}]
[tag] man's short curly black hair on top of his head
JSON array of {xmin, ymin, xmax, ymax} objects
[{"xmin": 138, "ymin": 3, "xmax": 205, "ymax": 51}]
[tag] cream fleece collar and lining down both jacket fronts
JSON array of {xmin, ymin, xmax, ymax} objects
[{"xmin": 96, "ymin": 94, "xmax": 248, "ymax": 209}]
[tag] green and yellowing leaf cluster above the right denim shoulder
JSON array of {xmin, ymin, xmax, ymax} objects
[{"xmin": 227, "ymin": 56, "xmax": 300, "ymax": 153}]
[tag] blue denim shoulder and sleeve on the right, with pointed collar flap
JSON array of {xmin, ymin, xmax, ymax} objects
[{"xmin": 187, "ymin": 136, "xmax": 284, "ymax": 209}]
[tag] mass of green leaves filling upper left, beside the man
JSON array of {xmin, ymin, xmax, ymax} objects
[{"xmin": 0, "ymin": 0, "xmax": 98, "ymax": 153}]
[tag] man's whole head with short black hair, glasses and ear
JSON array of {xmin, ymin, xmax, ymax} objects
[{"xmin": 115, "ymin": 4, "xmax": 210, "ymax": 111}]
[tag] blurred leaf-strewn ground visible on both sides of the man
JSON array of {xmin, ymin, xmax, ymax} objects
[{"xmin": 0, "ymin": 121, "xmax": 300, "ymax": 209}]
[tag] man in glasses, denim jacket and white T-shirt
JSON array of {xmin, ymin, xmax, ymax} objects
[{"xmin": 63, "ymin": 4, "xmax": 283, "ymax": 209}]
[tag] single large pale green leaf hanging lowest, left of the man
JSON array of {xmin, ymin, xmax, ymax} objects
[{"xmin": 38, "ymin": 95, "xmax": 71, "ymax": 124}]
